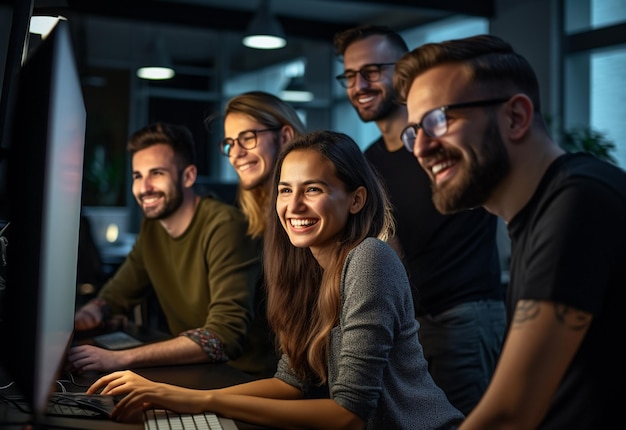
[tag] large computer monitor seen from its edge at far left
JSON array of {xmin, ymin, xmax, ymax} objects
[{"xmin": 0, "ymin": 18, "xmax": 86, "ymax": 424}]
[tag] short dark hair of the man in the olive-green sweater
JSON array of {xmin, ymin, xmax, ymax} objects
[{"xmin": 126, "ymin": 122, "xmax": 196, "ymax": 170}]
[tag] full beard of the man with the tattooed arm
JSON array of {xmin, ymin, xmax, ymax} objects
[{"xmin": 432, "ymin": 117, "xmax": 511, "ymax": 214}]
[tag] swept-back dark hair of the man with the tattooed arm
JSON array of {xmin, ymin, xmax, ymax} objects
[{"xmin": 393, "ymin": 35, "xmax": 541, "ymax": 113}]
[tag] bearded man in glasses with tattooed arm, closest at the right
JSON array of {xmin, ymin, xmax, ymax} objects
[{"xmin": 394, "ymin": 35, "xmax": 626, "ymax": 430}]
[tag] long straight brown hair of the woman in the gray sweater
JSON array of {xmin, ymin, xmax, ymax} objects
[{"xmin": 264, "ymin": 131, "xmax": 394, "ymax": 384}]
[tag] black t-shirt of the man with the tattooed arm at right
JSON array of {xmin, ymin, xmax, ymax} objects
[{"xmin": 506, "ymin": 154, "xmax": 626, "ymax": 429}]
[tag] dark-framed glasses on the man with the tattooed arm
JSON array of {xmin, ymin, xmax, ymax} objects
[{"xmin": 400, "ymin": 97, "xmax": 510, "ymax": 152}]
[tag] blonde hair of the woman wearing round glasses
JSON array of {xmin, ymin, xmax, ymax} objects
[{"xmin": 205, "ymin": 91, "xmax": 305, "ymax": 238}]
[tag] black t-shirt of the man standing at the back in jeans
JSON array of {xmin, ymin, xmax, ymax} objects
[{"xmin": 365, "ymin": 138, "xmax": 504, "ymax": 315}]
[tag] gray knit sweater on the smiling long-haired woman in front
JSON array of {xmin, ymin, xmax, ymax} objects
[{"xmin": 276, "ymin": 238, "xmax": 463, "ymax": 430}]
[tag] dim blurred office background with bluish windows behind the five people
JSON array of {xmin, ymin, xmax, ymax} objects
[{"xmin": 0, "ymin": 0, "xmax": 626, "ymax": 272}]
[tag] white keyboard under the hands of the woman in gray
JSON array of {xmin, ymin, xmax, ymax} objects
[{"xmin": 144, "ymin": 409, "xmax": 237, "ymax": 430}]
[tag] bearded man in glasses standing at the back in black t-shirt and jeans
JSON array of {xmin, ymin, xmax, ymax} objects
[{"xmin": 334, "ymin": 26, "xmax": 505, "ymax": 414}]
